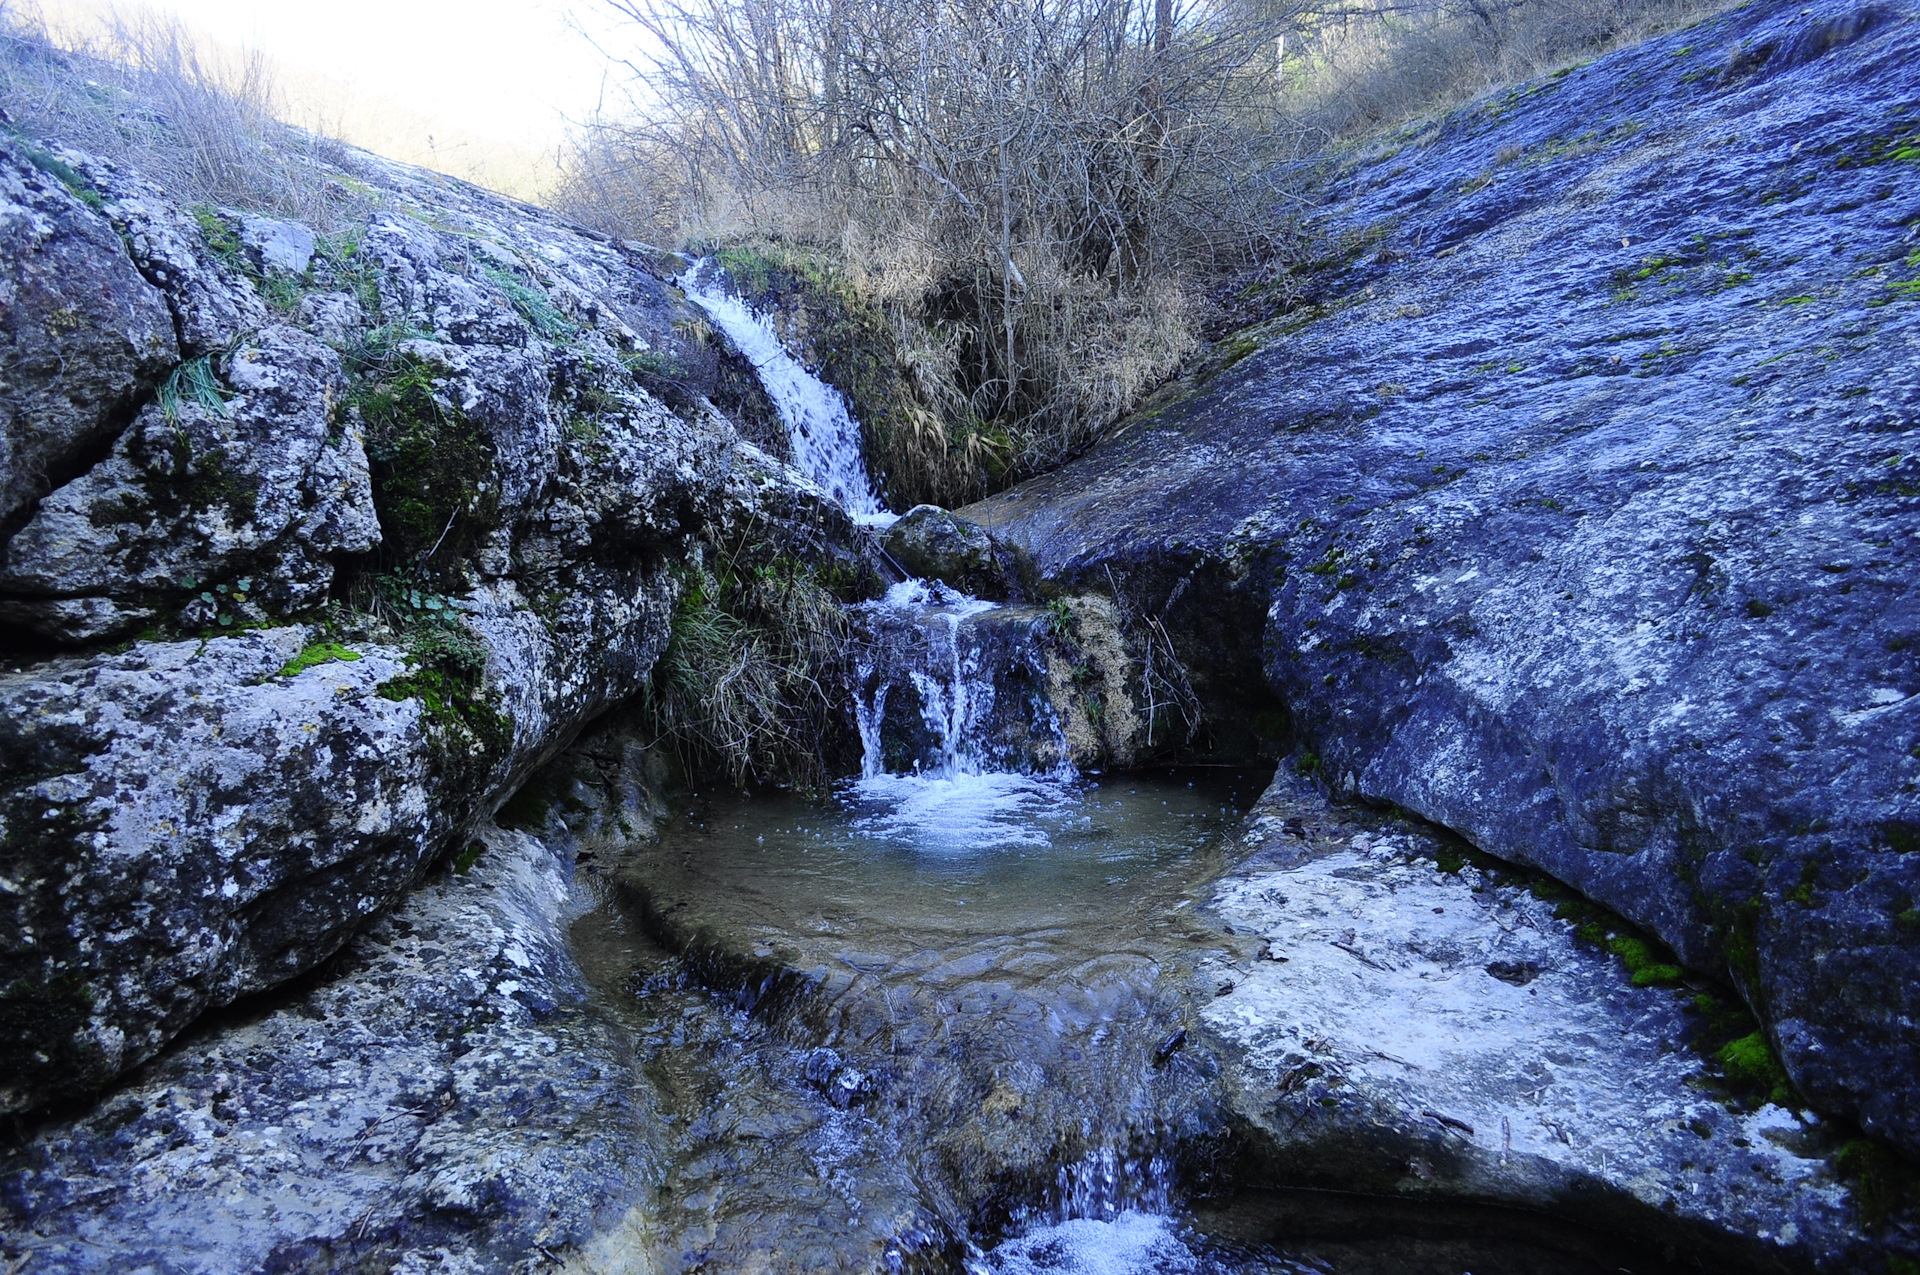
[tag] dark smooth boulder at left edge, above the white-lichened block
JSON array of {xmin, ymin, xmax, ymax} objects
[{"xmin": 0, "ymin": 138, "xmax": 179, "ymax": 543}]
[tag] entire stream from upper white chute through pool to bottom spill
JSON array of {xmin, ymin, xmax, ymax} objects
[{"xmin": 599, "ymin": 263, "xmax": 1258, "ymax": 1275}]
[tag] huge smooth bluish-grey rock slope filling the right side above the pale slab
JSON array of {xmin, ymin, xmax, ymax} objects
[{"xmin": 962, "ymin": 0, "xmax": 1920, "ymax": 1150}]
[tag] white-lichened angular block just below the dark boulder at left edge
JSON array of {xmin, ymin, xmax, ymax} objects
[{"xmin": 0, "ymin": 326, "xmax": 380, "ymax": 641}]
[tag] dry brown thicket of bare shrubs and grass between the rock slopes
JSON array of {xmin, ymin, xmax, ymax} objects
[{"xmin": 557, "ymin": 0, "xmax": 1699, "ymax": 505}]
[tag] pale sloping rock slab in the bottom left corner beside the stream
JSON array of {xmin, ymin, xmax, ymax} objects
[{"xmin": 0, "ymin": 818, "xmax": 657, "ymax": 1275}]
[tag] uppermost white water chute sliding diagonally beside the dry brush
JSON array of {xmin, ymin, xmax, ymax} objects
[{"xmin": 680, "ymin": 261, "xmax": 899, "ymax": 526}]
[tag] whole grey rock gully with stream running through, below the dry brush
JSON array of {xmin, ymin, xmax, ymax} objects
[{"xmin": 0, "ymin": 0, "xmax": 1920, "ymax": 1275}]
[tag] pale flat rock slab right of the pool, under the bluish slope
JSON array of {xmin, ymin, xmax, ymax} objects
[{"xmin": 1200, "ymin": 774, "xmax": 1889, "ymax": 1271}]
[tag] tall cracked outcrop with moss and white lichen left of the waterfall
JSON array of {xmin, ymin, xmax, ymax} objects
[{"xmin": 0, "ymin": 124, "xmax": 856, "ymax": 1112}]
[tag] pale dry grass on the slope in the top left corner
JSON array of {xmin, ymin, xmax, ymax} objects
[{"xmin": 0, "ymin": 4, "xmax": 346, "ymax": 229}]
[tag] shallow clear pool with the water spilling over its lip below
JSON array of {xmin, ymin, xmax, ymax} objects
[{"xmin": 574, "ymin": 768, "xmax": 1267, "ymax": 1271}]
